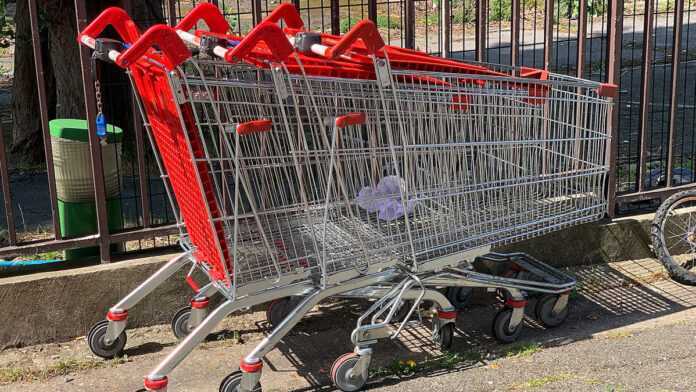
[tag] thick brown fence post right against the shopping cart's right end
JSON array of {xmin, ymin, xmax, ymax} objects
[{"xmin": 607, "ymin": 0, "xmax": 623, "ymax": 218}]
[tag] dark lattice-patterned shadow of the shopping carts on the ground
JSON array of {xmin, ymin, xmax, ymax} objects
[{"xmin": 246, "ymin": 259, "xmax": 696, "ymax": 391}]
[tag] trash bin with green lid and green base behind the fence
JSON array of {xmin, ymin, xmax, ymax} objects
[{"xmin": 49, "ymin": 119, "xmax": 123, "ymax": 260}]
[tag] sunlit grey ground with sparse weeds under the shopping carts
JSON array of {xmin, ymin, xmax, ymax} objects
[{"xmin": 0, "ymin": 260, "xmax": 696, "ymax": 392}]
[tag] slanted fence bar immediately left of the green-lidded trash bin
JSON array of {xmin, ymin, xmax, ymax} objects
[{"xmin": 28, "ymin": 0, "xmax": 63, "ymax": 240}]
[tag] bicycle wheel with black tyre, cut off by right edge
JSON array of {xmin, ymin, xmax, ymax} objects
[{"xmin": 650, "ymin": 189, "xmax": 696, "ymax": 286}]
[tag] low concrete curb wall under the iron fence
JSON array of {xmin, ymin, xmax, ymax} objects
[{"xmin": 0, "ymin": 215, "xmax": 654, "ymax": 349}]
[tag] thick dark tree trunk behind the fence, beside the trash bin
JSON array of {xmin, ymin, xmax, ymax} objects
[{"xmin": 12, "ymin": 0, "xmax": 164, "ymax": 163}]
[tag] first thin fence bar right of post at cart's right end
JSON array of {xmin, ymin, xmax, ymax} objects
[{"xmin": 638, "ymin": 0, "xmax": 654, "ymax": 192}]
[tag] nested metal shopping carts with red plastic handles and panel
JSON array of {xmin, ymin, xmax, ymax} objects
[{"xmin": 80, "ymin": 3, "xmax": 612, "ymax": 391}]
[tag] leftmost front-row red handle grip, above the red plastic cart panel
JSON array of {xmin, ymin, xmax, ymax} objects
[{"xmin": 116, "ymin": 25, "xmax": 191, "ymax": 70}]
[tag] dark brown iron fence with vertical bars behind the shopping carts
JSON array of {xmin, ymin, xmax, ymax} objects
[{"xmin": 0, "ymin": 0, "xmax": 696, "ymax": 262}]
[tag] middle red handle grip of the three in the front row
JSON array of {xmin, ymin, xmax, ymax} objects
[{"xmin": 225, "ymin": 22, "xmax": 294, "ymax": 63}]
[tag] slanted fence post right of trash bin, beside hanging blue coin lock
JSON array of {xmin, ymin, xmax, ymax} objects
[{"xmin": 75, "ymin": 0, "xmax": 111, "ymax": 263}]
